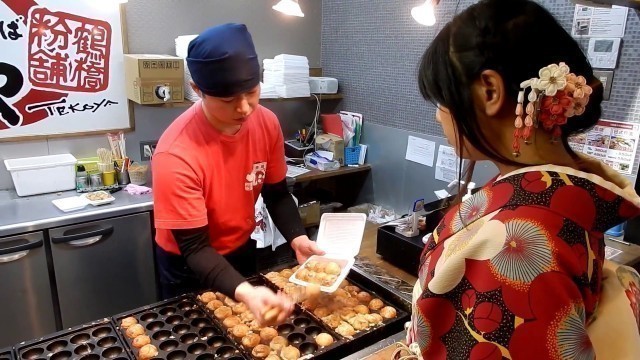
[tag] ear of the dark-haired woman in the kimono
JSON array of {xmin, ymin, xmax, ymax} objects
[{"xmin": 472, "ymin": 70, "xmax": 507, "ymax": 116}]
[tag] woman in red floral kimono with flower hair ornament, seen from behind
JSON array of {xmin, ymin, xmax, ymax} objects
[{"xmin": 407, "ymin": 0, "xmax": 640, "ymax": 360}]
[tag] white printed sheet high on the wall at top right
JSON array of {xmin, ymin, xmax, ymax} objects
[{"xmin": 571, "ymin": 5, "xmax": 629, "ymax": 38}]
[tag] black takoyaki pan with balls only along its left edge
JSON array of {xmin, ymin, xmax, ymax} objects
[{"xmin": 112, "ymin": 295, "xmax": 245, "ymax": 360}]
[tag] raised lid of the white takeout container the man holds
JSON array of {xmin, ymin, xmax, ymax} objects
[{"xmin": 317, "ymin": 213, "xmax": 367, "ymax": 258}]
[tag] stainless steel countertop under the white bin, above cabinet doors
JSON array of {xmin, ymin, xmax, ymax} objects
[{"xmin": 0, "ymin": 190, "xmax": 153, "ymax": 237}]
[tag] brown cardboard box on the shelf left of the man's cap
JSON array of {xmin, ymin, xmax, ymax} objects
[{"xmin": 124, "ymin": 54, "xmax": 184, "ymax": 105}]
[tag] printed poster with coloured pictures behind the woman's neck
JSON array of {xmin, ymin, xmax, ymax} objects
[{"xmin": 569, "ymin": 120, "xmax": 640, "ymax": 175}]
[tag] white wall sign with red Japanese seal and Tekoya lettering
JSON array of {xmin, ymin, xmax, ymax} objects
[{"xmin": 0, "ymin": 0, "xmax": 131, "ymax": 141}]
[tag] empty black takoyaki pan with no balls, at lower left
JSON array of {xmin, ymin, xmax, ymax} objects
[{"xmin": 15, "ymin": 319, "xmax": 131, "ymax": 360}]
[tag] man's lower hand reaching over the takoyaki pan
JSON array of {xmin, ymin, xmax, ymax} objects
[{"xmin": 235, "ymin": 282, "xmax": 294, "ymax": 326}]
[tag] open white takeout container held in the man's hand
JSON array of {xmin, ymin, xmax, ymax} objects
[{"xmin": 289, "ymin": 213, "xmax": 367, "ymax": 293}]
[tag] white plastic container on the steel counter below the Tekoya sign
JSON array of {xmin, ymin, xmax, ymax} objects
[{"xmin": 4, "ymin": 154, "xmax": 77, "ymax": 196}]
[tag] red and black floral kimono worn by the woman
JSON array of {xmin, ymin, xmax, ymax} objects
[{"xmin": 407, "ymin": 166, "xmax": 640, "ymax": 360}]
